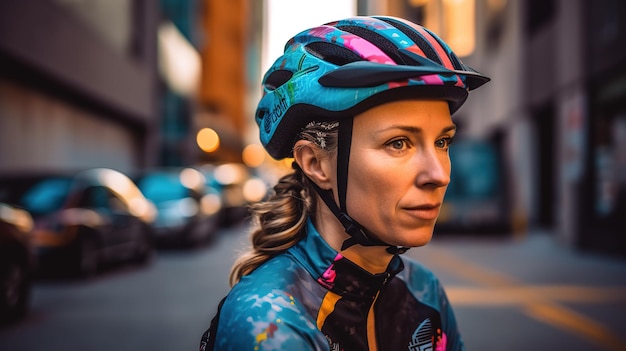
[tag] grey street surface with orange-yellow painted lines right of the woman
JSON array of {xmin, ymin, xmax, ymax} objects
[{"xmin": 406, "ymin": 233, "xmax": 626, "ymax": 351}]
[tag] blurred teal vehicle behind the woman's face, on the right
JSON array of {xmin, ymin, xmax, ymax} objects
[{"xmin": 435, "ymin": 139, "xmax": 512, "ymax": 235}]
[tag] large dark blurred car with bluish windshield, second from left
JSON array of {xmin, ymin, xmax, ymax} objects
[{"xmin": 0, "ymin": 168, "xmax": 156, "ymax": 276}]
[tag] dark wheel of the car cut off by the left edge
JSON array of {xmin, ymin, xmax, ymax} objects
[{"xmin": 0, "ymin": 260, "xmax": 30, "ymax": 323}]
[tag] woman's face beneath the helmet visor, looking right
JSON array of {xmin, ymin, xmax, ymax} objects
[{"xmin": 347, "ymin": 100, "xmax": 456, "ymax": 247}]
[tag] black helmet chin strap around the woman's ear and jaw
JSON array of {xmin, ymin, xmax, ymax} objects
[{"xmin": 303, "ymin": 118, "xmax": 409, "ymax": 255}]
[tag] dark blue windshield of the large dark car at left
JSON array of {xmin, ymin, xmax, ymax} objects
[{"xmin": 20, "ymin": 178, "xmax": 71, "ymax": 215}]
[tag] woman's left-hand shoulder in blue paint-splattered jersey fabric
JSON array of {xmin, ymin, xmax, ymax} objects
[{"xmin": 216, "ymin": 255, "xmax": 327, "ymax": 350}]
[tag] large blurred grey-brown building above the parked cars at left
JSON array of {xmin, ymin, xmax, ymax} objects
[{"xmin": 0, "ymin": 0, "xmax": 158, "ymax": 173}]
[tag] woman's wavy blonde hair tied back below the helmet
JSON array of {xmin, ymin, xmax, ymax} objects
[{"xmin": 230, "ymin": 122, "xmax": 338, "ymax": 286}]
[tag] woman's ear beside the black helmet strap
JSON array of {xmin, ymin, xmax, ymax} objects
[{"xmin": 293, "ymin": 140, "xmax": 332, "ymax": 190}]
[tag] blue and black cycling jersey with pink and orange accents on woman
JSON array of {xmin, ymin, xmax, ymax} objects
[{"xmin": 201, "ymin": 221, "xmax": 464, "ymax": 351}]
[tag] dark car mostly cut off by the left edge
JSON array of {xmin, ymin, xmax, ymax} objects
[{"xmin": 0, "ymin": 203, "xmax": 35, "ymax": 324}]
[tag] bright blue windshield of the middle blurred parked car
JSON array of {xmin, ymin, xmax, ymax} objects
[{"xmin": 137, "ymin": 174, "xmax": 189, "ymax": 203}]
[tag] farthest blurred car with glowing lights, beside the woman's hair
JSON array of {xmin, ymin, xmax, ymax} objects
[{"xmin": 200, "ymin": 163, "xmax": 270, "ymax": 226}]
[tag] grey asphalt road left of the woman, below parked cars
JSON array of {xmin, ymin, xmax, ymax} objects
[{"xmin": 0, "ymin": 226, "xmax": 247, "ymax": 351}]
